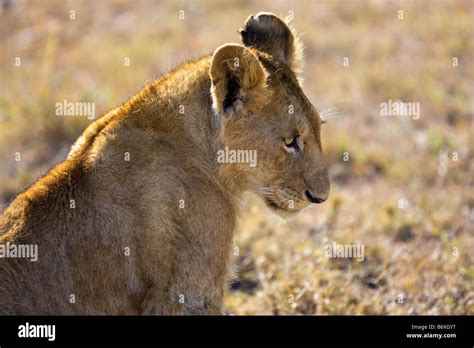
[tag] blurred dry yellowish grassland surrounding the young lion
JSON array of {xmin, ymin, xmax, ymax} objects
[{"xmin": 0, "ymin": 0, "xmax": 474, "ymax": 314}]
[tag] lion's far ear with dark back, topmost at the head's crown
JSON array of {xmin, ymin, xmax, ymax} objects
[{"xmin": 239, "ymin": 12, "xmax": 303, "ymax": 71}]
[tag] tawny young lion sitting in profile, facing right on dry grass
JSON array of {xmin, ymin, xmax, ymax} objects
[{"xmin": 0, "ymin": 13, "xmax": 329, "ymax": 315}]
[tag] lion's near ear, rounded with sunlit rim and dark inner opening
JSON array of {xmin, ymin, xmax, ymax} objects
[{"xmin": 210, "ymin": 44, "xmax": 266, "ymax": 116}]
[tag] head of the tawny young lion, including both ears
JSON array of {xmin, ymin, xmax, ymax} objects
[{"xmin": 210, "ymin": 13, "xmax": 329, "ymax": 216}]
